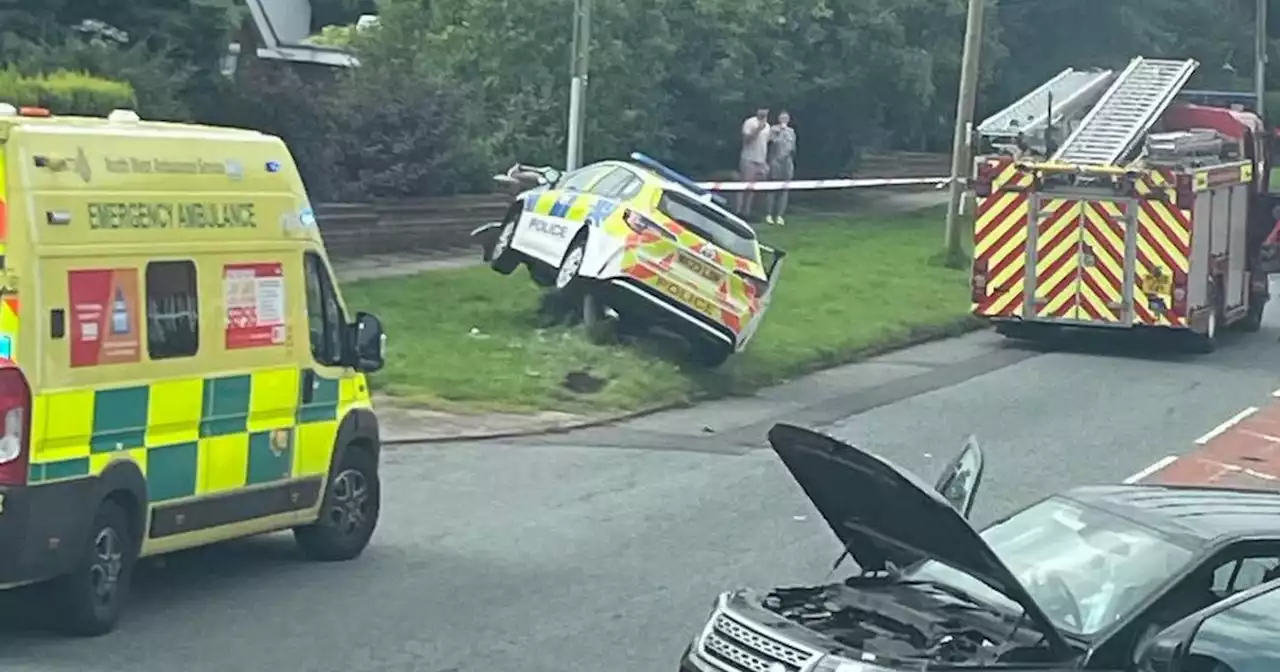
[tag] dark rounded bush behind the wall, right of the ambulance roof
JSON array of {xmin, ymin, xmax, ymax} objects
[{"xmin": 201, "ymin": 63, "xmax": 494, "ymax": 202}]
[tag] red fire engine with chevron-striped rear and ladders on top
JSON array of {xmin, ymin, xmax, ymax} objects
[{"xmin": 972, "ymin": 58, "xmax": 1266, "ymax": 349}]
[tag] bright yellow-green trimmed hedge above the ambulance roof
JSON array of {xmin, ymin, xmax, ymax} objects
[{"xmin": 0, "ymin": 68, "xmax": 137, "ymax": 116}]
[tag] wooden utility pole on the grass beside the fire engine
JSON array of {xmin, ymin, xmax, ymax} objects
[{"xmin": 946, "ymin": 0, "xmax": 984, "ymax": 266}]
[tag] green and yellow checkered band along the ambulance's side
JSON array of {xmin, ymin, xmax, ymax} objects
[{"xmin": 29, "ymin": 367, "xmax": 353, "ymax": 504}]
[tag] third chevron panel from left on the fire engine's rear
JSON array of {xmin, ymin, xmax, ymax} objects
[{"xmin": 1078, "ymin": 201, "xmax": 1128, "ymax": 323}]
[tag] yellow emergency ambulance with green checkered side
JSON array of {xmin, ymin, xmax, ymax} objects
[{"xmin": 0, "ymin": 102, "xmax": 384, "ymax": 635}]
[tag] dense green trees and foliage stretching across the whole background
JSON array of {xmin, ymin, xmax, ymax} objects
[{"xmin": 0, "ymin": 0, "xmax": 1280, "ymax": 197}]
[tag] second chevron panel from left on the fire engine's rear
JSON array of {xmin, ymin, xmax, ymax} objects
[{"xmin": 1034, "ymin": 198, "xmax": 1080, "ymax": 320}]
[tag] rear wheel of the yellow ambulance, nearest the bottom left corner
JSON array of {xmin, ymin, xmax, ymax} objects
[{"xmin": 52, "ymin": 499, "xmax": 138, "ymax": 637}]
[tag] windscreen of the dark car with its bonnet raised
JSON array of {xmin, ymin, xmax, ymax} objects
[{"xmin": 909, "ymin": 498, "xmax": 1194, "ymax": 636}]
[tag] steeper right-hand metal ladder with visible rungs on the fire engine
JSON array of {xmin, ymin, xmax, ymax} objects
[{"xmin": 1051, "ymin": 56, "xmax": 1199, "ymax": 166}]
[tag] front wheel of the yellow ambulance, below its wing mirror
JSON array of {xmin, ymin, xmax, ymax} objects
[{"xmin": 293, "ymin": 447, "xmax": 381, "ymax": 562}]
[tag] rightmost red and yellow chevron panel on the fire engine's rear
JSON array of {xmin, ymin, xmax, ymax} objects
[{"xmin": 1133, "ymin": 200, "xmax": 1192, "ymax": 326}]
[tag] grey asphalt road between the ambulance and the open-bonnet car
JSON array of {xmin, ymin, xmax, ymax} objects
[{"xmin": 0, "ymin": 308, "xmax": 1280, "ymax": 672}]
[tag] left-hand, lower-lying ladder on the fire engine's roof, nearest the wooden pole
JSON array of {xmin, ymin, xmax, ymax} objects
[{"xmin": 978, "ymin": 68, "xmax": 1115, "ymax": 138}]
